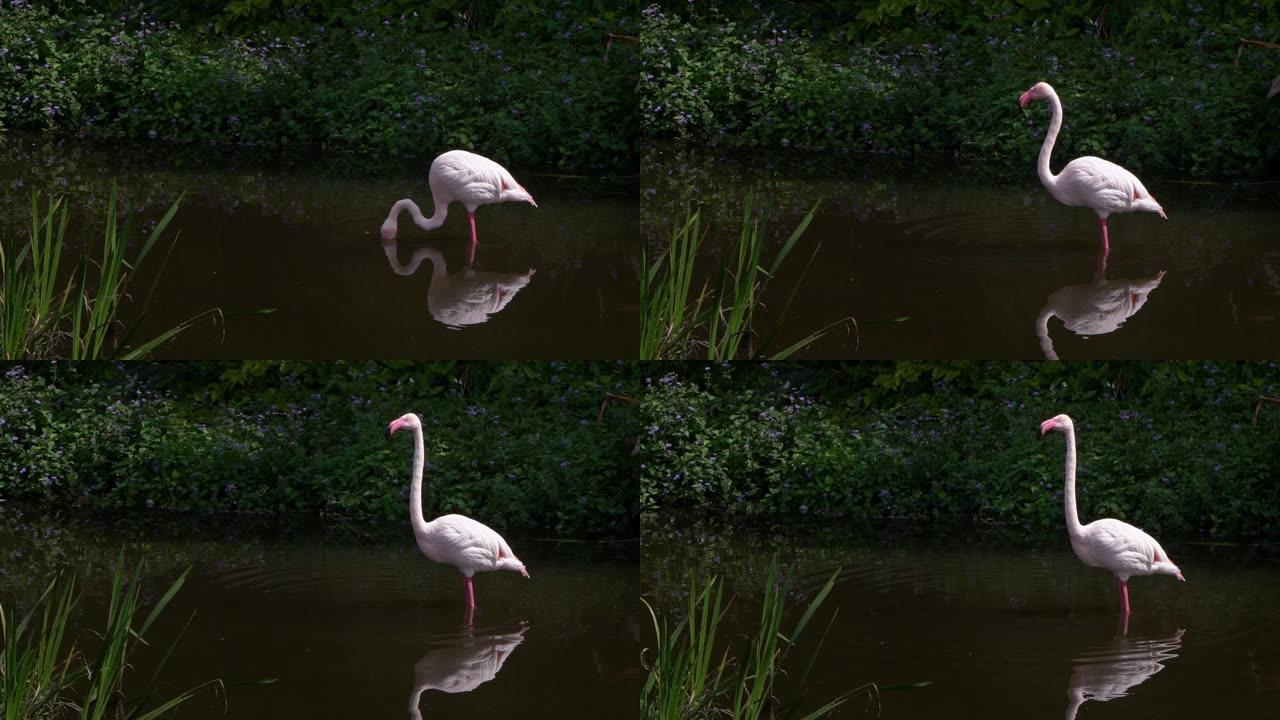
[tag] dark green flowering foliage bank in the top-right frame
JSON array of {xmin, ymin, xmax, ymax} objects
[{"xmin": 640, "ymin": 0, "xmax": 1280, "ymax": 176}]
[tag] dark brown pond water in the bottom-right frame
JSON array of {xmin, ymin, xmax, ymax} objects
[{"xmin": 641, "ymin": 518, "xmax": 1280, "ymax": 720}]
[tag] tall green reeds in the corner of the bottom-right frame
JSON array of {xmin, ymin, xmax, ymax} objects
[{"xmin": 640, "ymin": 559, "xmax": 878, "ymax": 720}]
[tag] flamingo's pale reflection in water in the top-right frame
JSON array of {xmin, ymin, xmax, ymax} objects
[{"xmin": 1036, "ymin": 251, "xmax": 1165, "ymax": 360}]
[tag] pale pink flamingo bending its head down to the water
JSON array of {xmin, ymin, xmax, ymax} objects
[{"xmin": 381, "ymin": 150, "xmax": 538, "ymax": 265}]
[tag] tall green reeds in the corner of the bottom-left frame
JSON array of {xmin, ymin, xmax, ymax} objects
[{"xmin": 0, "ymin": 555, "xmax": 221, "ymax": 720}]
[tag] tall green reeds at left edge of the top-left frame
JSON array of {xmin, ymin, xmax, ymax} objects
[{"xmin": 0, "ymin": 182, "xmax": 220, "ymax": 360}]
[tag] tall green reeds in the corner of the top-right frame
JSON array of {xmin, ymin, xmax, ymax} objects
[{"xmin": 640, "ymin": 195, "xmax": 854, "ymax": 360}]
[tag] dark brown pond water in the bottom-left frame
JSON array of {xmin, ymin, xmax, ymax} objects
[{"xmin": 0, "ymin": 510, "xmax": 645, "ymax": 719}]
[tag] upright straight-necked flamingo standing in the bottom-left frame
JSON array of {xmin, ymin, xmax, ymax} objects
[{"xmin": 387, "ymin": 413, "xmax": 529, "ymax": 611}]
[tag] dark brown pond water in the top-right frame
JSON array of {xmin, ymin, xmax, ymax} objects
[{"xmin": 641, "ymin": 147, "xmax": 1280, "ymax": 360}]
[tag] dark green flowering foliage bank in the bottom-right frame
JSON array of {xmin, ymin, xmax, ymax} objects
[{"xmin": 640, "ymin": 363, "xmax": 1280, "ymax": 537}]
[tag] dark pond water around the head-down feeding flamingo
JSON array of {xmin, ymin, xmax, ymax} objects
[{"xmin": 0, "ymin": 137, "xmax": 639, "ymax": 360}]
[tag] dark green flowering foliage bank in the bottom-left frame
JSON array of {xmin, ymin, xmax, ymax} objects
[{"xmin": 0, "ymin": 363, "xmax": 639, "ymax": 534}]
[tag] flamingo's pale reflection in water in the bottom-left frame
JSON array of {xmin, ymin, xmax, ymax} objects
[{"xmin": 408, "ymin": 621, "xmax": 529, "ymax": 720}]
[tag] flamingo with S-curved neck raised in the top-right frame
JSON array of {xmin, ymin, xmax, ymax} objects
[{"xmin": 1018, "ymin": 82, "xmax": 1169, "ymax": 258}]
